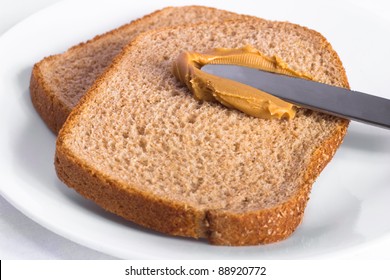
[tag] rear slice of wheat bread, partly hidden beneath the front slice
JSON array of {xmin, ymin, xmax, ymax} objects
[{"xmin": 30, "ymin": 6, "xmax": 245, "ymax": 133}]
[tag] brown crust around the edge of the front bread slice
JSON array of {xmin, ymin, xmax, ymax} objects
[{"xmin": 55, "ymin": 17, "xmax": 349, "ymax": 246}]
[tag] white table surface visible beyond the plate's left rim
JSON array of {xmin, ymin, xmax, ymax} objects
[{"xmin": 0, "ymin": 0, "xmax": 114, "ymax": 260}]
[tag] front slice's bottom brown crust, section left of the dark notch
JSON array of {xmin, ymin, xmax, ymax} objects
[{"xmin": 55, "ymin": 141, "xmax": 205, "ymax": 238}]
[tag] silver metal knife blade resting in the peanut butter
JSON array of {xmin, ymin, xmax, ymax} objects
[{"xmin": 201, "ymin": 64, "xmax": 390, "ymax": 129}]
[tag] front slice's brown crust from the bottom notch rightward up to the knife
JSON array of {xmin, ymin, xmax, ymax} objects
[{"xmin": 207, "ymin": 121, "xmax": 348, "ymax": 246}]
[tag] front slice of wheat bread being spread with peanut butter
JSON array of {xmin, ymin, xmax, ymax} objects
[{"xmin": 55, "ymin": 19, "xmax": 348, "ymax": 245}]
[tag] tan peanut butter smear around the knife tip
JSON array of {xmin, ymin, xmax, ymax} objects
[{"xmin": 173, "ymin": 46, "xmax": 312, "ymax": 119}]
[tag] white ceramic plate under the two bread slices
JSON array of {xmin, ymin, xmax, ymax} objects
[{"xmin": 0, "ymin": 0, "xmax": 390, "ymax": 259}]
